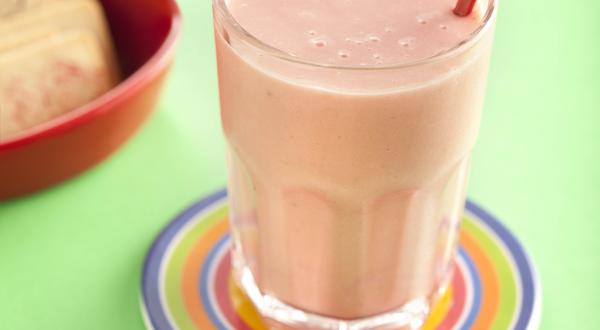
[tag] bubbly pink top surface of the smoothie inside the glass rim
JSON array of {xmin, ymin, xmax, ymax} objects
[{"xmin": 227, "ymin": 0, "xmax": 480, "ymax": 66}]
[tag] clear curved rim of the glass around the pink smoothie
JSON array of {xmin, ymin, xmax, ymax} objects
[{"xmin": 212, "ymin": 0, "xmax": 499, "ymax": 71}]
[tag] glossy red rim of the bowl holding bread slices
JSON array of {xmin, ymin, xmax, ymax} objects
[{"xmin": 0, "ymin": 0, "xmax": 182, "ymax": 152}]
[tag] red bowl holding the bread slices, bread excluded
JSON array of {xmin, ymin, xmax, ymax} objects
[{"xmin": 0, "ymin": 0, "xmax": 181, "ymax": 199}]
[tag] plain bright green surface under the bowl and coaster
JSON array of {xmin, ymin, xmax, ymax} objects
[{"xmin": 0, "ymin": 0, "xmax": 600, "ymax": 330}]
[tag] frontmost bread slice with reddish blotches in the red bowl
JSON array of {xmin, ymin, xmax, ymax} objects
[{"xmin": 0, "ymin": 29, "xmax": 115, "ymax": 140}]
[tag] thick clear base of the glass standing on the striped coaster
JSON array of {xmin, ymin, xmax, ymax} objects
[{"xmin": 237, "ymin": 267, "xmax": 430, "ymax": 330}]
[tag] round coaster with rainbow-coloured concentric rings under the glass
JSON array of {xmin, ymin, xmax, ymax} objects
[{"xmin": 141, "ymin": 191, "xmax": 541, "ymax": 330}]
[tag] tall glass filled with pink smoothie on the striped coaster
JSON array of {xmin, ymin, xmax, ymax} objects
[{"xmin": 214, "ymin": 0, "xmax": 495, "ymax": 329}]
